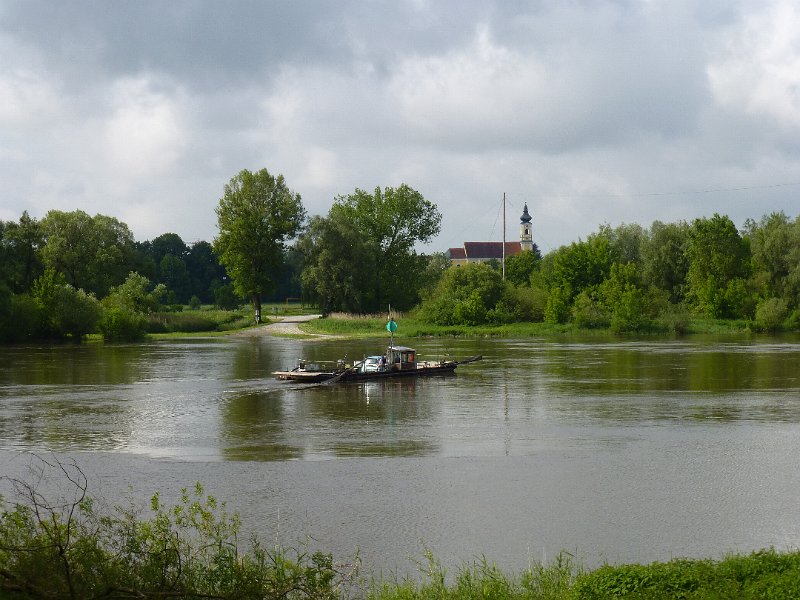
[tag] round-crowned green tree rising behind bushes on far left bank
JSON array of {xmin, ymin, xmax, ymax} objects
[{"xmin": 41, "ymin": 210, "xmax": 134, "ymax": 297}]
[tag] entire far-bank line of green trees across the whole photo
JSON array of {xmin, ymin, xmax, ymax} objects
[{"xmin": 0, "ymin": 164, "xmax": 800, "ymax": 341}]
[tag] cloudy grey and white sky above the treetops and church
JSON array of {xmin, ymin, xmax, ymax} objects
[{"xmin": 0, "ymin": 0, "xmax": 800, "ymax": 253}]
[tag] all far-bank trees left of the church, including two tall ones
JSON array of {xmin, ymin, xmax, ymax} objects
[{"xmin": 0, "ymin": 169, "xmax": 441, "ymax": 341}]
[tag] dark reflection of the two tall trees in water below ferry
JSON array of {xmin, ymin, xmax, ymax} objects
[{"xmin": 221, "ymin": 380, "xmax": 435, "ymax": 460}]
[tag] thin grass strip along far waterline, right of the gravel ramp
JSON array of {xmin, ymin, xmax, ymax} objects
[{"xmin": 301, "ymin": 314, "xmax": 750, "ymax": 338}]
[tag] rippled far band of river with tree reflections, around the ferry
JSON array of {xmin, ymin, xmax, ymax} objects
[{"xmin": 0, "ymin": 338, "xmax": 800, "ymax": 461}]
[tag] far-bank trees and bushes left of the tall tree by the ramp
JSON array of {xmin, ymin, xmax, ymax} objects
[{"xmin": 0, "ymin": 210, "xmax": 238, "ymax": 341}]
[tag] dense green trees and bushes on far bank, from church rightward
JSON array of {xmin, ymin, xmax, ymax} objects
[{"xmin": 428, "ymin": 212, "xmax": 800, "ymax": 333}]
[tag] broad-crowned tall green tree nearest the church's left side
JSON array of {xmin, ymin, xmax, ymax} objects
[{"xmin": 302, "ymin": 184, "xmax": 442, "ymax": 313}]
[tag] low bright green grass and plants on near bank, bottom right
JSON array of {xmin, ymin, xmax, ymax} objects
[{"xmin": 368, "ymin": 550, "xmax": 800, "ymax": 600}]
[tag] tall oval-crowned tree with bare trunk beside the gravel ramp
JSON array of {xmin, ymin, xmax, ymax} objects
[{"xmin": 213, "ymin": 169, "xmax": 305, "ymax": 314}]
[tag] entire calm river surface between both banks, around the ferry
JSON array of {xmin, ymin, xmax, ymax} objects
[{"xmin": 0, "ymin": 337, "xmax": 800, "ymax": 574}]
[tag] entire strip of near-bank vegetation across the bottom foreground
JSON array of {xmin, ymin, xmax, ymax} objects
[{"xmin": 0, "ymin": 458, "xmax": 800, "ymax": 600}]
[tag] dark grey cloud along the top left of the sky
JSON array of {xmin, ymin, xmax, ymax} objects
[{"xmin": 2, "ymin": 0, "xmax": 488, "ymax": 87}]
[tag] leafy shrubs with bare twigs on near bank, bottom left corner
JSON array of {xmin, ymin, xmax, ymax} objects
[{"xmin": 0, "ymin": 459, "xmax": 357, "ymax": 600}]
